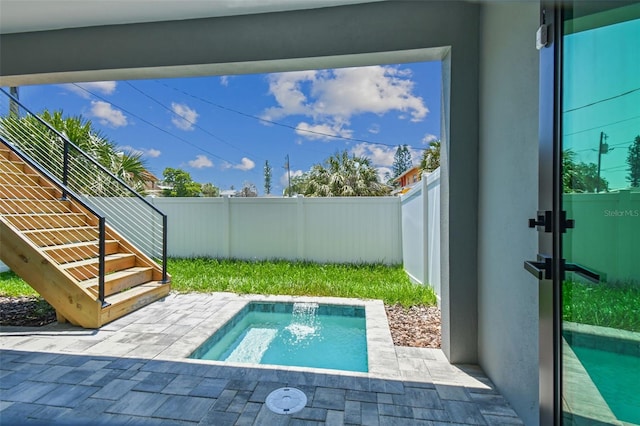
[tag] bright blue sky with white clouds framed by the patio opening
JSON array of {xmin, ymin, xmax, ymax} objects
[{"xmin": 20, "ymin": 62, "xmax": 441, "ymax": 195}]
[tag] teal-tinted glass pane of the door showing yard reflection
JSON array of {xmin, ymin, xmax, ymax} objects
[{"xmin": 562, "ymin": 2, "xmax": 640, "ymax": 425}]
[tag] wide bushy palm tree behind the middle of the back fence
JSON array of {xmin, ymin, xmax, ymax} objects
[{"xmin": 292, "ymin": 151, "xmax": 390, "ymax": 197}]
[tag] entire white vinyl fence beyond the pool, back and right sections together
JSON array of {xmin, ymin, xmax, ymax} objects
[{"xmin": 0, "ymin": 188, "xmax": 440, "ymax": 288}]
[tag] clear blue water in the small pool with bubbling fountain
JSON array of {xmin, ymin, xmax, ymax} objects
[{"xmin": 190, "ymin": 302, "xmax": 368, "ymax": 372}]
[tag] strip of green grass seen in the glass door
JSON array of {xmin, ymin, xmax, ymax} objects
[{"xmin": 562, "ymin": 282, "xmax": 640, "ymax": 332}]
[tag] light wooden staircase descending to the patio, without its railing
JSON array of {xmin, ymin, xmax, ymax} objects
[{"xmin": 0, "ymin": 142, "xmax": 170, "ymax": 328}]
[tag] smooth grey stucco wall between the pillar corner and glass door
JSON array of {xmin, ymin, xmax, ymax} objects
[{"xmin": 478, "ymin": 3, "xmax": 539, "ymax": 425}]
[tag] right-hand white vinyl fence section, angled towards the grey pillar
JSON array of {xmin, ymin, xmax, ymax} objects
[{"xmin": 401, "ymin": 169, "xmax": 440, "ymax": 303}]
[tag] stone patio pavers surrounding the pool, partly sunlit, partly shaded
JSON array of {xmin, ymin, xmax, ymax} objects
[{"xmin": 0, "ymin": 293, "xmax": 522, "ymax": 425}]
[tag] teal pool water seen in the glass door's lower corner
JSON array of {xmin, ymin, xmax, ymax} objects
[{"xmin": 572, "ymin": 346, "xmax": 640, "ymax": 425}]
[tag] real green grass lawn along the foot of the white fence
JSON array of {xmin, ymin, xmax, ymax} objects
[{"xmin": 0, "ymin": 258, "xmax": 436, "ymax": 307}]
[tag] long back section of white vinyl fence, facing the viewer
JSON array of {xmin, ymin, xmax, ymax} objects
[{"xmin": 150, "ymin": 197, "xmax": 402, "ymax": 265}]
